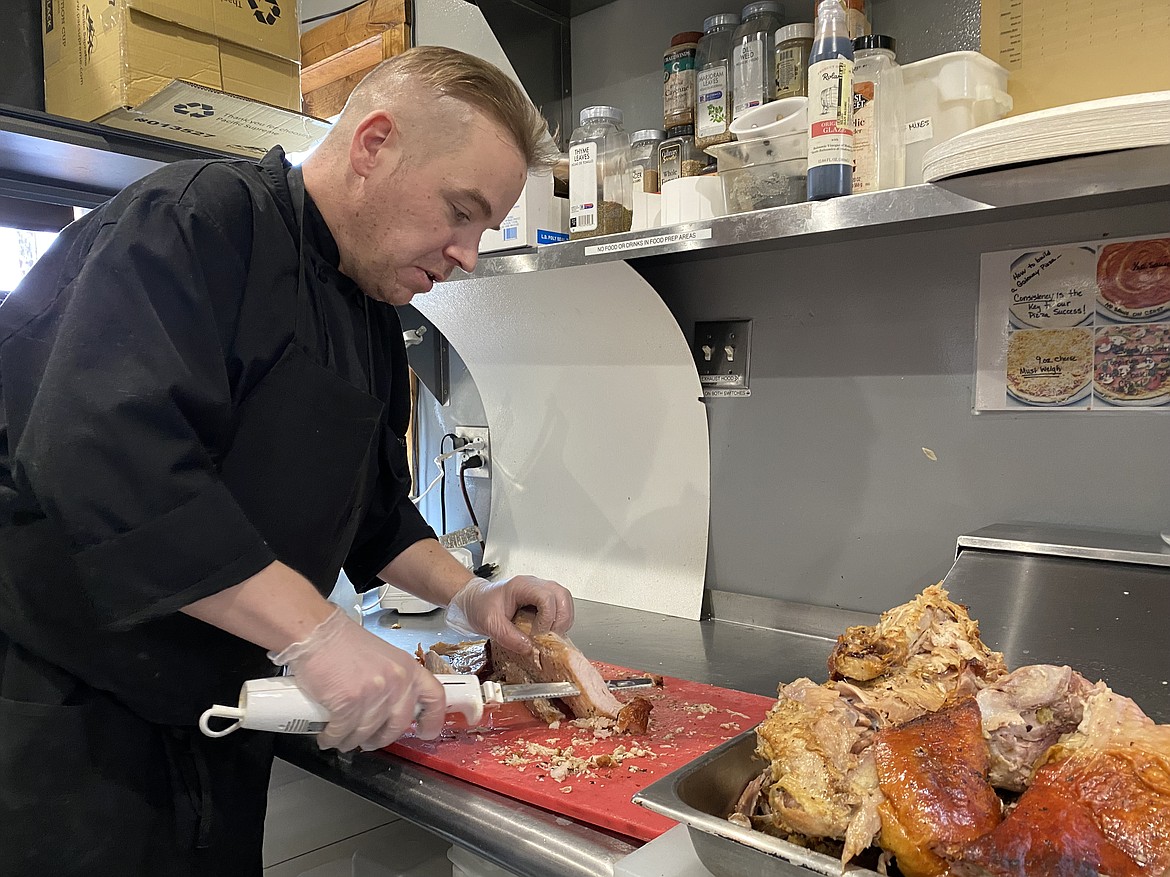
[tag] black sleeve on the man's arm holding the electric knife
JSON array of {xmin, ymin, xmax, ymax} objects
[{"xmin": 5, "ymin": 176, "xmax": 275, "ymax": 629}]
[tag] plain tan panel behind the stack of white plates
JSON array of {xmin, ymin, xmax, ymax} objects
[{"xmin": 979, "ymin": 0, "xmax": 1170, "ymax": 116}]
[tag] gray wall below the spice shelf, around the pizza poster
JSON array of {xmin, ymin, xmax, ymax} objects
[{"xmin": 634, "ymin": 205, "xmax": 1170, "ymax": 612}]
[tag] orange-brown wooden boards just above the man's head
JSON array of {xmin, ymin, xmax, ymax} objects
[{"xmin": 301, "ymin": 0, "xmax": 411, "ymax": 118}]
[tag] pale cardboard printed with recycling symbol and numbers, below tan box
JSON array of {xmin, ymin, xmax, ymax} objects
[{"xmin": 97, "ymin": 82, "xmax": 330, "ymax": 158}]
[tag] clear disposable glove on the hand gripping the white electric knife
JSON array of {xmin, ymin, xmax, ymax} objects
[{"xmin": 269, "ymin": 609, "xmax": 447, "ymax": 752}]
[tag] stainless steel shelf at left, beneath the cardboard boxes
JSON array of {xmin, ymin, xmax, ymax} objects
[{"xmin": 0, "ymin": 105, "xmax": 238, "ymax": 207}]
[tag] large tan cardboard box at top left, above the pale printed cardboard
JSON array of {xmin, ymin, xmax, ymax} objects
[{"xmin": 42, "ymin": 0, "xmax": 301, "ymax": 122}]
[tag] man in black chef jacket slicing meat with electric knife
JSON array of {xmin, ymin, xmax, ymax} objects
[{"xmin": 0, "ymin": 48, "xmax": 572, "ymax": 877}]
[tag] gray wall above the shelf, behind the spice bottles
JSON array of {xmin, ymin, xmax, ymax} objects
[{"xmin": 571, "ymin": 0, "xmax": 979, "ymax": 131}]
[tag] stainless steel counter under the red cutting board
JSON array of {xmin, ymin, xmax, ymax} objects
[{"xmin": 277, "ymin": 600, "xmax": 842, "ymax": 877}]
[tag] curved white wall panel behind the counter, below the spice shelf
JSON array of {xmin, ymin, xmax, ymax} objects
[{"xmin": 413, "ymin": 262, "xmax": 710, "ymax": 619}]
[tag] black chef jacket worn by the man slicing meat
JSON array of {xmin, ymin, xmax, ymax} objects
[{"xmin": 0, "ymin": 150, "xmax": 434, "ymax": 725}]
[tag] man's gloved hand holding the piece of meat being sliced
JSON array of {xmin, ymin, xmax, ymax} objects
[{"xmin": 447, "ymin": 575, "xmax": 573, "ymax": 652}]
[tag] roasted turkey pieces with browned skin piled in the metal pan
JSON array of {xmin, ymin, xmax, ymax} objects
[{"xmin": 729, "ymin": 586, "xmax": 1170, "ymax": 877}]
